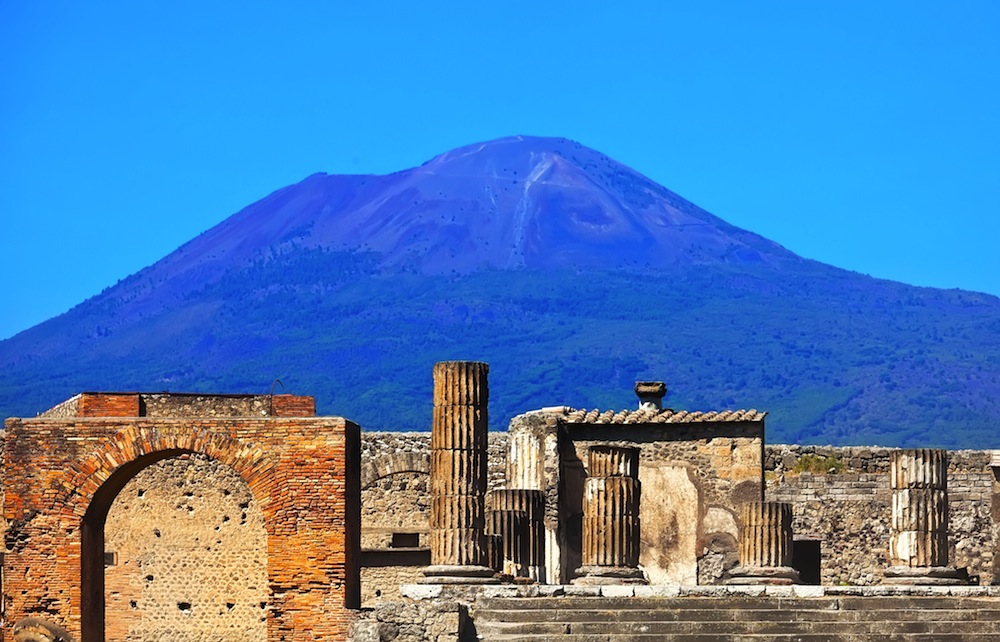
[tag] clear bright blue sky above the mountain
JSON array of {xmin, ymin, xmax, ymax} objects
[{"xmin": 0, "ymin": 0, "xmax": 1000, "ymax": 338}]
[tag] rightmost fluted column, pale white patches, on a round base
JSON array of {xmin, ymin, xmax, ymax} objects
[{"xmin": 885, "ymin": 449, "xmax": 965, "ymax": 584}]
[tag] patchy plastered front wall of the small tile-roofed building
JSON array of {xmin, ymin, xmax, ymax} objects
[{"xmin": 560, "ymin": 422, "xmax": 763, "ymax": 584}]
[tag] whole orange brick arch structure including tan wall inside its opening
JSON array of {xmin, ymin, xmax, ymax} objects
[{"xmin": 3, "ymin": 393, "xmax": 360, "ymax": 642}]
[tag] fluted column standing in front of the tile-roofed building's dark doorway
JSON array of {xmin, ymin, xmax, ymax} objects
[{"xmin": 573, "ymin": 446, "xmax": 645, "ymax": 584}]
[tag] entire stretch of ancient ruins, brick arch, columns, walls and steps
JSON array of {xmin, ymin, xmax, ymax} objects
[{"xmin": 0, "ymin": 362, "xmax": 1000, "ymax": 642}]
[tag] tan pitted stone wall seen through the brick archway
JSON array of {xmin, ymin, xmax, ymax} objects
[{"xmin": 104, "ymin": 454, "xmax": 268, "ymax": 642}]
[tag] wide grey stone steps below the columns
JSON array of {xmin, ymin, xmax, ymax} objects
[{"xmin": 474, "ymin": 595, "xmax": 1000, "ymax": 642}]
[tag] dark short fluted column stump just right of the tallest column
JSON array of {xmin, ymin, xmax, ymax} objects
[{"xmin": 487, "ymin": 489, "xmax": 545, "ymax": 582}]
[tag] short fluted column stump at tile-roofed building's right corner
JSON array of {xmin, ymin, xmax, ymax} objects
[{"xmin": 727, "ymin": 502, "xmax": 799, "ymax": 584}]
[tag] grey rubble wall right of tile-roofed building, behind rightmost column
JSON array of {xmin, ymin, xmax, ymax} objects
[{"xmin": 765, "ymin": 445, "xmax": 1000, "ymax": 585}]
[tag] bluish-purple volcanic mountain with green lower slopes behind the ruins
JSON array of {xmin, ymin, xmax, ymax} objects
[{"xmin": 0, "ymin": 137, "xmax": 1000, "ymax": 448}]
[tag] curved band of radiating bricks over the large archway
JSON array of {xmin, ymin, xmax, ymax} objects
[{"xmin": 64, "ymin": 426, "xmax": 274, "ymax": 519}]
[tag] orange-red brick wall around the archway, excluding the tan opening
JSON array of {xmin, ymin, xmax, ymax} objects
[{"xmin": 4, "ymin": 417, "xmax": 360, "ymax": 642}]
